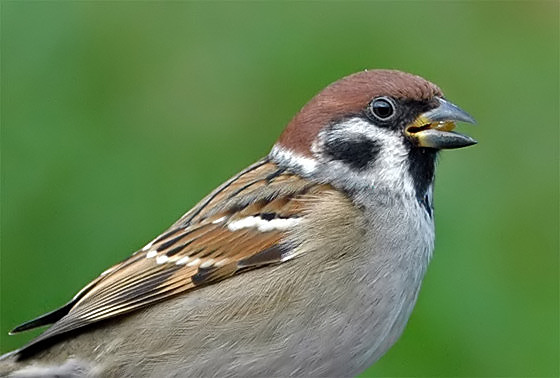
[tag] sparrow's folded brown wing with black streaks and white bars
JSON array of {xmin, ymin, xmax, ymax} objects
[{"xmin": 12, "ymin": 159, "xmax": 327, "ymax": 349}]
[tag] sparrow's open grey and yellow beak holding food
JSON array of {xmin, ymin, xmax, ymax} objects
[{"xmin": 405, "ymin": 97, "xmax": 477, "ymax": 149}]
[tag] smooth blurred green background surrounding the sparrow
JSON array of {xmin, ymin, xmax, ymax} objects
[{"xmin": 0, "ymin": 1, "xmax": 559, "ymax": 377}]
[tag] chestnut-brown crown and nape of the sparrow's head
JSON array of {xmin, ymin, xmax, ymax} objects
[{"xmin": 278, "ymin": 70, "xmax": 443, "ymax": 156}]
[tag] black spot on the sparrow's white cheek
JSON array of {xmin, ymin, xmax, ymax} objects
[{"xmin": 325, "ymin": 138, "xmax": 381, "ymax": 170}]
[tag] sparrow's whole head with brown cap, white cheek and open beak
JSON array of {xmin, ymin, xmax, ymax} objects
[{"xmin": 271, "ymin": 70, "xmax": 476, "ymax": 196}]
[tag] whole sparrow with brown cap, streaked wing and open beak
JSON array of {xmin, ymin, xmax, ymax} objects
[{"xmin": 0, "ymin": 69, "xmax": 477, "ymax": 377}]
